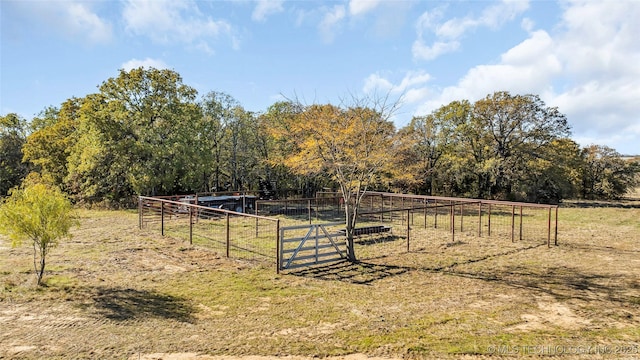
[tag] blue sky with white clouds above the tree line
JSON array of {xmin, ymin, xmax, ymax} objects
[{"xmin": 0, "ymin": 0, "xmax": 640, "ymax": 155}]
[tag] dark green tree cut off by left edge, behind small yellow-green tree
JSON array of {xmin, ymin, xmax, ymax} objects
[{"xmin": 0, "ymin": 113, "xmax": 28, "ymax": 198}]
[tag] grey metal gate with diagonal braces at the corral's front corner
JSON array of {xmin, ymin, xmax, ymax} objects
[{"xmin": 278, "ymin": 223, "xmax": 347, "ymax": 271}]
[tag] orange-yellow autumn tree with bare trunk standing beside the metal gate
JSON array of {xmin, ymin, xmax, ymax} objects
[{"xmin": 276, "ymin": 99, "xmax": 397, "ymax": 261}]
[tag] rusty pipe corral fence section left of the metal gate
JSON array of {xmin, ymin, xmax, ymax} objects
[{"xmin": 138, "ymin": 196, "xmax": 280, "ymax": 263}]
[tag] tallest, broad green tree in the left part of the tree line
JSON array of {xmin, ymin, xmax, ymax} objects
[{"xmin": 67, "ymin": 68, "xmax": 201, "ymax": 202}]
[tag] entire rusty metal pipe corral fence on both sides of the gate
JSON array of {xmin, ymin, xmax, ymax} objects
[{"xmin": 139, "ymin": 192, "xmax": 558, "ymax": 269}]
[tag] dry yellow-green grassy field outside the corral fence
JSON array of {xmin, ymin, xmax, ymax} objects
[{"xmin": 0, "ymin": 194, "xmax": 640, "ymax": 359}]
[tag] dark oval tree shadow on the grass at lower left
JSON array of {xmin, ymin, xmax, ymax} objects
[{"xmin": 93, "ymin": 287, "xmax": 196, "ymax": 323}]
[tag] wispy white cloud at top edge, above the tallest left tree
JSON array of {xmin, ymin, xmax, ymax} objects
[{"xmin": 122, "ymin": 0, "xmax": 237, "ymax": 48}]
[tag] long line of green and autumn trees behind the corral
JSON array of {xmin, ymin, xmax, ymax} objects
[{"xmin": 0, "ymin": 68, "xmax": 640, "ymax": 206}]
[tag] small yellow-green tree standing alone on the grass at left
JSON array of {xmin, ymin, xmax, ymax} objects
[{"xmin": 0, "ymin": 180, "xmax": 77, "ymax": 285}]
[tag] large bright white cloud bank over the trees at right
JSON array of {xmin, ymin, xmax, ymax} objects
[{"xmin": 408, "ymin": 1, "xmax": 640, "ymax": 153}]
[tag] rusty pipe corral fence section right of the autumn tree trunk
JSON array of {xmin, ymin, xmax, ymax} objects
[{"xmin": 318, "ymin": 192, "xmax": 558, "ymax": 260}]
